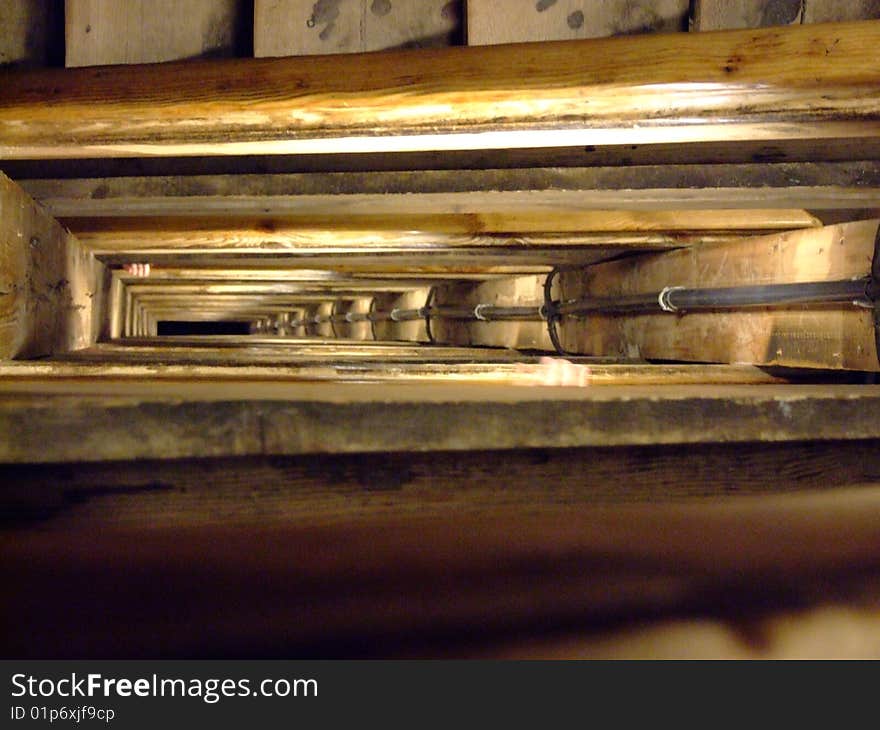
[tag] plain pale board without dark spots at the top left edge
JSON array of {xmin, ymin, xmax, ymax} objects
[{"xmin": 65, "ymin": 0, "xmax": 249, "ymax": 66}]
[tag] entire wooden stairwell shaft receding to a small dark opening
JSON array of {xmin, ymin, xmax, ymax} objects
[{"xmin": 0, "ymin": 0, "xmax": 880, "ymax": 658}]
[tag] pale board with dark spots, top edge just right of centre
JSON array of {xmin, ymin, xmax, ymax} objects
[{"xmin": 467, "ymin": 0, "xmax": 689, "ymax": 46}]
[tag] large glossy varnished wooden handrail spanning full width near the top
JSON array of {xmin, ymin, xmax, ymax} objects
[{"xmin": 0, "ymin": 21, "xmax": 880, "ymax": 159}]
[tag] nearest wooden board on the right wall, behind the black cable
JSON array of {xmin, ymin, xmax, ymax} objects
[{"xmin": 560, "ymin": 220, "xmax": 880, "ymax": 371}]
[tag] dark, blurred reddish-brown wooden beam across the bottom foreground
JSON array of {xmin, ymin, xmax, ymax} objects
[{"xmin": 0, "ymin": 456, "xmax": 880, "ymax": 659}]
